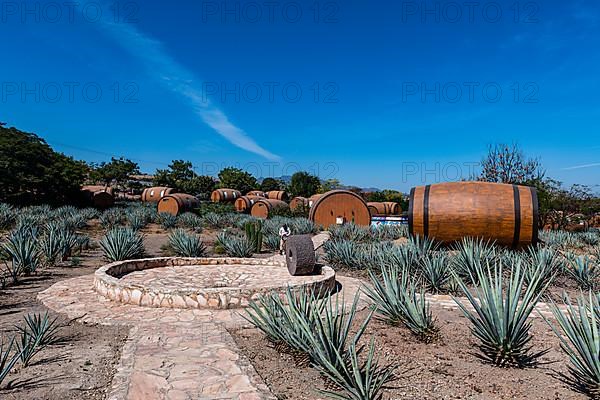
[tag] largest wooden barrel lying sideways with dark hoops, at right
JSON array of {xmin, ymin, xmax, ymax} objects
[{"xmin": 408, "ymin": 182, "xmax": 538, "ymax": 248}]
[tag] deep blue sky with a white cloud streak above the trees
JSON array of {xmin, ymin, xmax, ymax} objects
[{"xmin": 0, "ymin": 0, "xmax": 600, "ymax": 191}]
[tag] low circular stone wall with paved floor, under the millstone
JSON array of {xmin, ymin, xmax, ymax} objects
[{"xmin": 94, "ymin": 257, "xmax": 335, "ymax": 309}]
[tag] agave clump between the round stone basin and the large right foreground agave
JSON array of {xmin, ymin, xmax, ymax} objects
[{"xmin": 362, "ymin": 267, "xmax": 438, "ymax": 342}]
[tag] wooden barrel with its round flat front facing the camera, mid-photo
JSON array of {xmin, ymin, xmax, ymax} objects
[{"xmin": 308, "ymin": 190, "xmax": 371, "ymax": 228}]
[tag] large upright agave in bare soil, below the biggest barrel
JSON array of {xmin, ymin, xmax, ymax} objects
[{"xmin": 454, "ymin": 261, "xmax": 548, "ymax": 368}]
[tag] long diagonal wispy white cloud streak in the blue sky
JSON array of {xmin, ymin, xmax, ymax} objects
[{"xmin": 88, "ymin": 7, "xmax": 280, "ymax": 161}]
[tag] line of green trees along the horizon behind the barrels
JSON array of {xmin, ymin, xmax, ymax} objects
[{"xmin": 0, "ymin": 124, "xmax": 600, "ymax": 229}]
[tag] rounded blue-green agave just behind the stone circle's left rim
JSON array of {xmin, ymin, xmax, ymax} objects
[{"xmin": 100, "ymin": 227, "xmax": 145, "ymax": 261}]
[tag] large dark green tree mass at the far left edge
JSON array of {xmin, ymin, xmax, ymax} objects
[{"xmin": 0, "ymin": 126, "xmax": 88, "ymax": 205}]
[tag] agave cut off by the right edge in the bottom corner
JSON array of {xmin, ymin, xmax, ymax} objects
[{"xmin": 546, "ymin": 292, "xmax": 600, "ymax": 399}]
